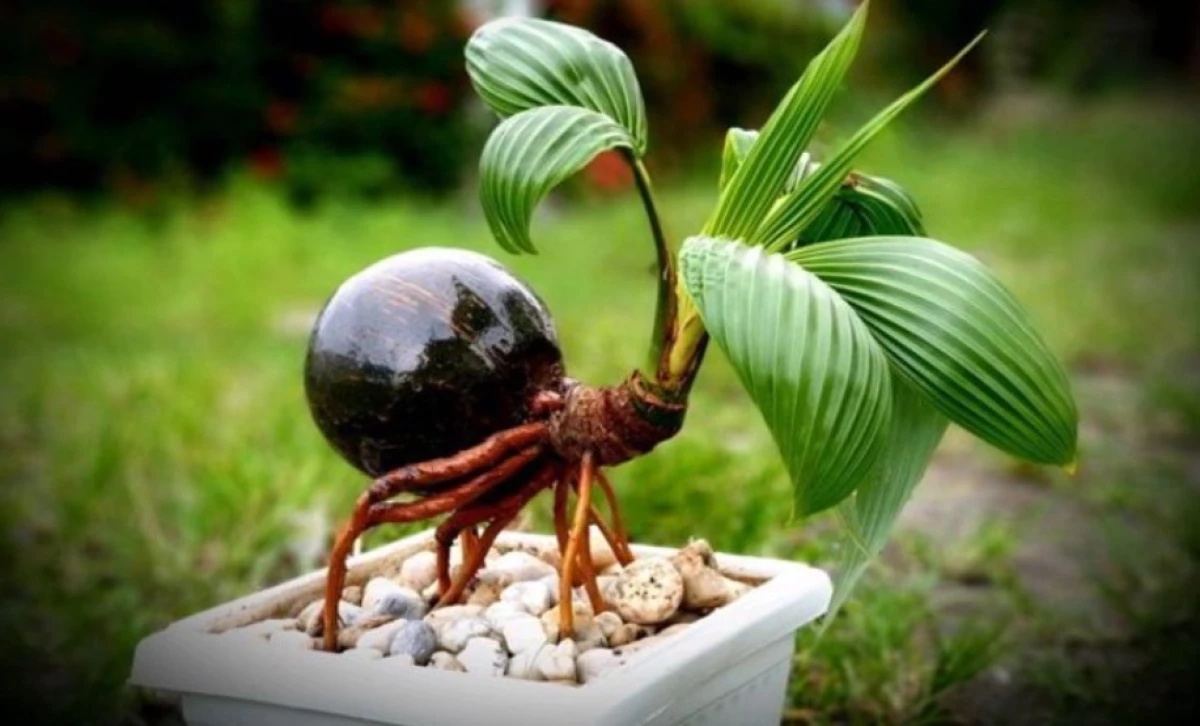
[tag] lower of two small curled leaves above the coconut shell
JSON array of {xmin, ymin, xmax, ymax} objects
[{"xmin": 479, "ymin": 106, "xmax": 634, "ymax": 253}]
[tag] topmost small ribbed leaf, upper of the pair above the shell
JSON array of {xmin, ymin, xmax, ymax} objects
[{"xmin": 467, "ymin": 18, "xmax": 646, "ymax": 156}]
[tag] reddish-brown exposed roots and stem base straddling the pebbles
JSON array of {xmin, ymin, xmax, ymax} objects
[{"xmin": 322, "ymin": 373, "xmax": 685, "ymax": 650}]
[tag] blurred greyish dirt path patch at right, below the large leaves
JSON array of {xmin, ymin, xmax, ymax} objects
[{"xmin": 898, "ymin": 367, "xmax": 1200, "ymax": 726}]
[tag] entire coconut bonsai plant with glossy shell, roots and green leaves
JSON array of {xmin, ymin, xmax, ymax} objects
[{"xmin": 306, "ymin": 2, "xmax": 1076, "ymax": 650}]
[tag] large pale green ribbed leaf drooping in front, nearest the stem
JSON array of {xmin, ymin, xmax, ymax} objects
[{"xmin": 680, "ymin": 238, "xmax": 890, "ymax": 515}]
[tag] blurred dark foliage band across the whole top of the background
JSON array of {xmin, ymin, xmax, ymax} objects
[{"xmin": 0, "ymin": 0, "xmax": 1200, "ymax": 202}]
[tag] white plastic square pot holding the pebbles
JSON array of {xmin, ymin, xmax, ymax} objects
[{"xmin": 131, "ymin": 532, "xmax": 830, "ymax": 726}]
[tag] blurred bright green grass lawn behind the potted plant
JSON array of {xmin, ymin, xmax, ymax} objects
[{"xmin": 0, "ymin": 93, "xmax": 1200, "ymax": 722}]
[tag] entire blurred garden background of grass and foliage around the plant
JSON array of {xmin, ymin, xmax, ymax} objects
[{"xmin": 0, "ymin": 0, "xmax": 1200, "ymax": 724}]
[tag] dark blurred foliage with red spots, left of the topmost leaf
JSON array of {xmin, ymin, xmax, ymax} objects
[{"xmin": 0, "ymin": 0, "xmax": 472, "ymax": 198}]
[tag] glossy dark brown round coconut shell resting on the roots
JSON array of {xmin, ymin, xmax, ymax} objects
[{"xmin": 305, "ymin": 247, "xmax": 563, "ymax": 476}]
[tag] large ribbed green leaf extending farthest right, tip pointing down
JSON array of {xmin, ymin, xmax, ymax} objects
[{"xmin": 787, "ymin": 238, "xmax": 1078, "ymax": 464}]
